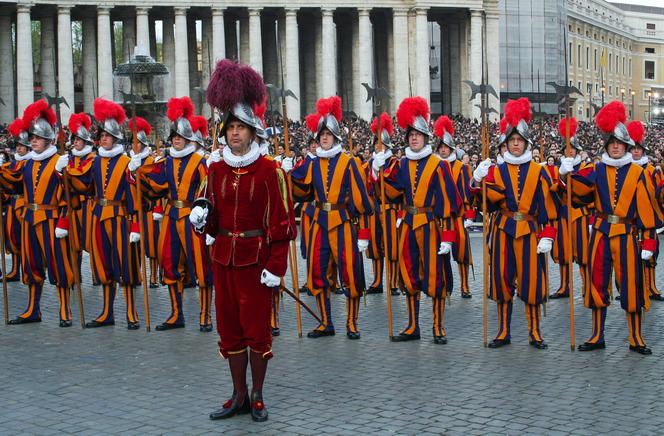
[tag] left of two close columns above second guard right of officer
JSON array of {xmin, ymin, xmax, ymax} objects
[{"xmin": 392, "ymin": 8, "xmax": 410, "ymax": 107}]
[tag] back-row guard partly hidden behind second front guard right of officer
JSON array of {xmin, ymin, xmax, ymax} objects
[{"xmin": 433, "ymin": 115, "xmax": 475, "ymax": 298}]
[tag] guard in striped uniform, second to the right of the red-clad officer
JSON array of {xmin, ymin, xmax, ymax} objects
[{"xmin": 372, "ymin": 97, "xmax": 461, "ymax": 344}]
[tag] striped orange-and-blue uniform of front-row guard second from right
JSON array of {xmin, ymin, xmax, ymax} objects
[{"xmin": 485, "ymin": 161, "xmax": 559, "ymax": 343}]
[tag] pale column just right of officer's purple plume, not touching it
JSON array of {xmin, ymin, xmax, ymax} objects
[{"xmin": 282, "ymin": 9, "xmax": 302, "ymax": 120}]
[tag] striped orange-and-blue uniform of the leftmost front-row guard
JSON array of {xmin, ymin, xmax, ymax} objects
[{"xmin": 0, "ymin": 149, "xmax": 74, "ymax": 321}]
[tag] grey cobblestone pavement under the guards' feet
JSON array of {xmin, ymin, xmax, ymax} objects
[{"xmin": 0, "ymin": 236, "xmax": 664, "ymax": 435}]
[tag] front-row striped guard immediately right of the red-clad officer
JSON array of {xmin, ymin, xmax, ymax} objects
[{"xmin": 282, "ymin": 96, "xmax": 373, "ymax": 339}]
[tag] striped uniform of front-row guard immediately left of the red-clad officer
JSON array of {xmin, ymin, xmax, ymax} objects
[{"xmin": 141, "ymin": 153, "xmax": 212, "ymax": 326}]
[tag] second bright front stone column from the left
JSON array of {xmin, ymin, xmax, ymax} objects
[{"xmin": 58, "ymin": 6, "xmax": 75, "ymax": 125}]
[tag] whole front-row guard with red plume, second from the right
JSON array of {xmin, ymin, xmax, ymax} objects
[{"xmin": 473, "ymin": 97, "xmax": 557, "ymax": 349}]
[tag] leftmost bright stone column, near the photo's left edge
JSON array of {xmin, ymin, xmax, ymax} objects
[{"xmin": 16, "ymin": 4, "xmax": 35, "ymax": 114}]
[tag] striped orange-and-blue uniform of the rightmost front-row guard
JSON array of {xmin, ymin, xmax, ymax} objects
[{"xmin": 572, "ymin": 162, "xmax": 662, "ymax": 346}]
